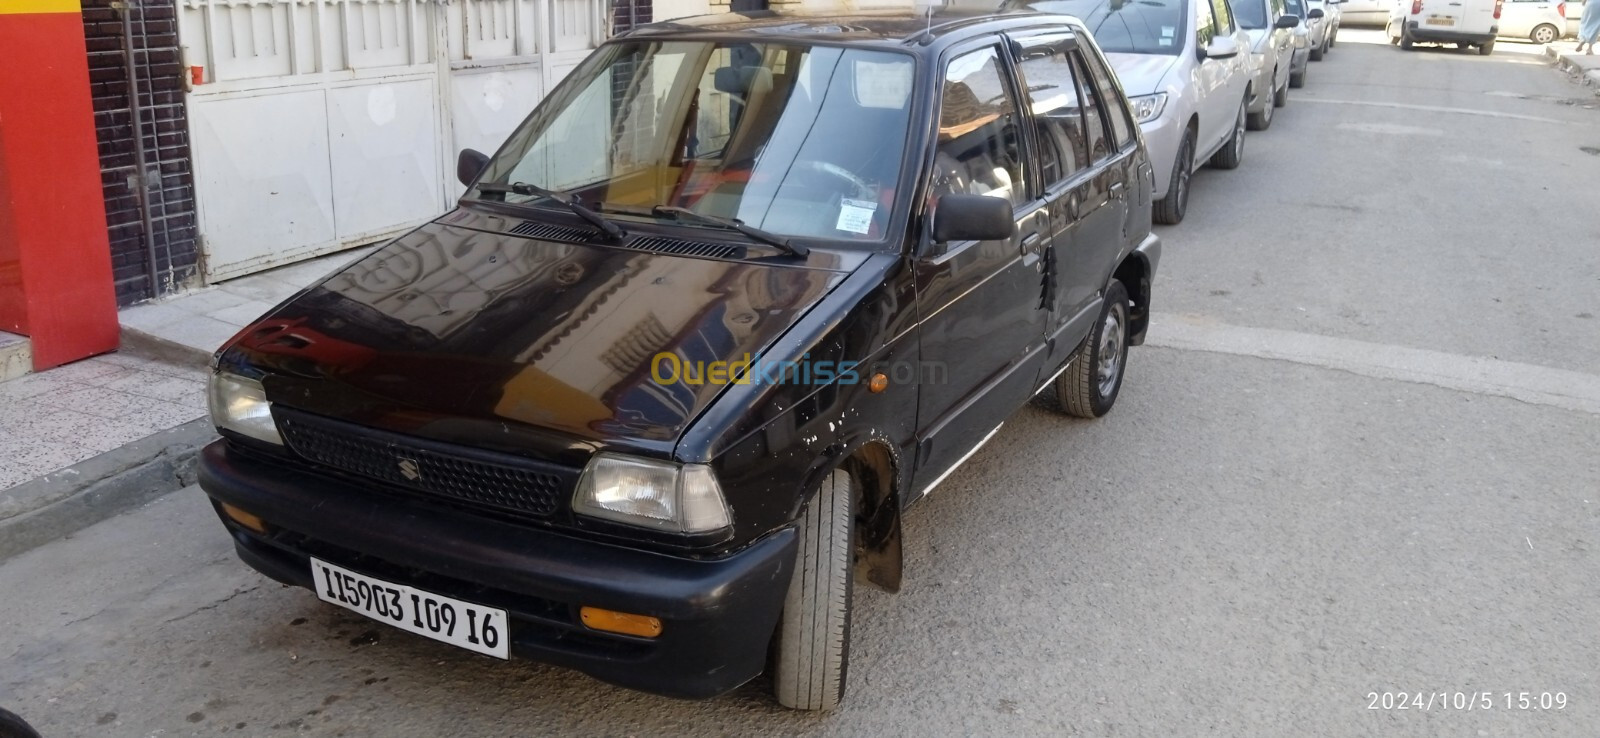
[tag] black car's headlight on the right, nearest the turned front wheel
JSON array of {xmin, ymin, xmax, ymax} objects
[{"xmin": 573, "ymin": 453, "xmax": 733, "ymax": 533}]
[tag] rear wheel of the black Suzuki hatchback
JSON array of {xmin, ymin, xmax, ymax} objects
[{"xmin": 1056, "ymin": 280, "xmax": 1128, "ymax": 418}]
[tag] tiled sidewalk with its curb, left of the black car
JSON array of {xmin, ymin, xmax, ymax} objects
[{"xmin": 0, "ymin": 247, "xmax": 376, "ymax": 559}]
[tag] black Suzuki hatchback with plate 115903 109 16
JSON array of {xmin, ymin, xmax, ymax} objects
[{"xmin": 200, "ymin": 10, "xmax": 1160, "ymax": 709}]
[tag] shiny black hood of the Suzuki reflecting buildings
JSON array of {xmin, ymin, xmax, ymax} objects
[{"xmin": 219, "ymin": 211, "xmax": 859, "ymax": 456}]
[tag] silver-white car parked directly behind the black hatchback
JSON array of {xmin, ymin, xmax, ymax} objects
[{"xmin": 1026, "ymin": 0, "xmax": 1254, "ymax": 224}]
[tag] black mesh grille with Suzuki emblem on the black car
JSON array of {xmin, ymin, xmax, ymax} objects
[{"xmin": 272, "ymin": 407, "xmax": 578, "ymax": 517}]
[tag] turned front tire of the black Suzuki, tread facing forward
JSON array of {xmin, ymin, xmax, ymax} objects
[{"xmin": 773, "ymin": 469, "xmax": 856, "ymax": 711}]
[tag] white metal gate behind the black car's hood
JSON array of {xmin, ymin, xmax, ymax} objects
[{"xmin": 179, "ymin": 0, "xmax": 603, "ymax": 282}]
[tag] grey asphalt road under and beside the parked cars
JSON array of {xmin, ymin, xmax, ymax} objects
[{"xmin": 0, "ymin": 29, "xmax": 1600, "ymax": 736}]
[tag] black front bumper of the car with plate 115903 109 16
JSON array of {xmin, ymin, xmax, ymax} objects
[{"xmin": 200, "ymin": 440, "xmax": 795, "ymax": 698}]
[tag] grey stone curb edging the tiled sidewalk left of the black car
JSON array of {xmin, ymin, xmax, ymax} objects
[{"xmin": 0, "ymin": 418, "xmax": 216, "ymax": 560}]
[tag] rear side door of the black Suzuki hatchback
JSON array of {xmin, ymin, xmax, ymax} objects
[{"xmin": 1016, "ymin": 32, "xmax": 1150, "ymax": 368}]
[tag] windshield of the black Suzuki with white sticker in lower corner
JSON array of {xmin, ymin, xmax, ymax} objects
[{"xmin": 469, "ymin": 40, "xmax": 914, "ymax": 242}]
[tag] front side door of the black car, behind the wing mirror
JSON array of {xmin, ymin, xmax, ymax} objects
[{"xmin": 914, "ymin": 37, "xmax": 1050, "ymax": 491}]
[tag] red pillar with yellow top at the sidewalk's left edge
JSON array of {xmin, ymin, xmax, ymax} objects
[{"xmin": 0, "ymin": 0, "xmax": 117, "ymax": 370}]
